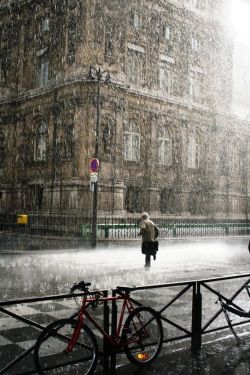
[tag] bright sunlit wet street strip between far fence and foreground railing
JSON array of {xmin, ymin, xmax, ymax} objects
[{"xmin": 0, "ymin": 237, "xmax": 250, "ymax": 300}]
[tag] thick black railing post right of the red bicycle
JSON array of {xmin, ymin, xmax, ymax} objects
[{"xmin": 191, "ymin": 281, "xmax": 202, "ymax": 353}]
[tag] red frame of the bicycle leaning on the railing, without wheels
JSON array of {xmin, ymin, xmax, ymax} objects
[{"xmin": 65, "ymin": 293, "xmax": 137, "ymax": 353}]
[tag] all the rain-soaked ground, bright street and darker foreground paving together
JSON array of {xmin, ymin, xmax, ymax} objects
[{"xmin": 0, "ymin": 237, "xmax": 250, "ymax": 375}]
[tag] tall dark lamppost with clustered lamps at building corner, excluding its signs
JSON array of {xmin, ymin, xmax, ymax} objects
[{"xmin": 87, "ymin": 66, "xmax": 110, "ymax": 248}]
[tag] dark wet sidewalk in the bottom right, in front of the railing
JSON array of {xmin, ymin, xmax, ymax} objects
[{"xmin": 108, "ymin": 335, "xmax": 250, "ymax": 375}]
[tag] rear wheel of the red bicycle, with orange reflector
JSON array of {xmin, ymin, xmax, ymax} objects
[{"xmin": 122, "ymin": 306, "xmax": 163, "ymax": 366}]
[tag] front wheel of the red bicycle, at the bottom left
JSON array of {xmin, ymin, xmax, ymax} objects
[{"xmin": 34, "ymin": 319, "xmax": 98, "ymax": 375}]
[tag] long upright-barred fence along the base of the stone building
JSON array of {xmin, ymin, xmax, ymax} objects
[{"xmin": 0, "ymin": 214, "xmax": 250, "ymax": 241}]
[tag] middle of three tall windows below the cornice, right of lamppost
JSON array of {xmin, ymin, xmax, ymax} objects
[{"xmin": 157, "ymin": 127, "xmax": 172, "ymax": 165}]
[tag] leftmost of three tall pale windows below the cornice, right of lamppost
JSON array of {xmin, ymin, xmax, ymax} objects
[{"xmin": 124, "ymin": 119, "xmax": 140, "ymax": 162}]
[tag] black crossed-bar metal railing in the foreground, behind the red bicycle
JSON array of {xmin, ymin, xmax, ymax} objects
[{"xmin": 0, "ymin": 273, "xmax": 250, "ymax": 375}]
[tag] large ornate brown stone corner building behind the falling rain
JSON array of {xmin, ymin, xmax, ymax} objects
[{"xmin": 0, "ymin": 0, "xmax": 250, "ymax": 219}]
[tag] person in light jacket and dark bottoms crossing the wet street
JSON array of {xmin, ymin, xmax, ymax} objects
[{"xmin": 139, "ymin": 212, "xmax": 159, "ymax": 267}]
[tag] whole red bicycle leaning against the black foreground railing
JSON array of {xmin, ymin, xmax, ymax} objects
[{"xmin": 34, "ymin": 281, "xmax": 163, "ymax": 375}]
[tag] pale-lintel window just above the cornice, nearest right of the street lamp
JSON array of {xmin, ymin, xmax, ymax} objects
[{"xmin": 127, "ymin": 44, "xmax": 145, "ymax": 85}]
